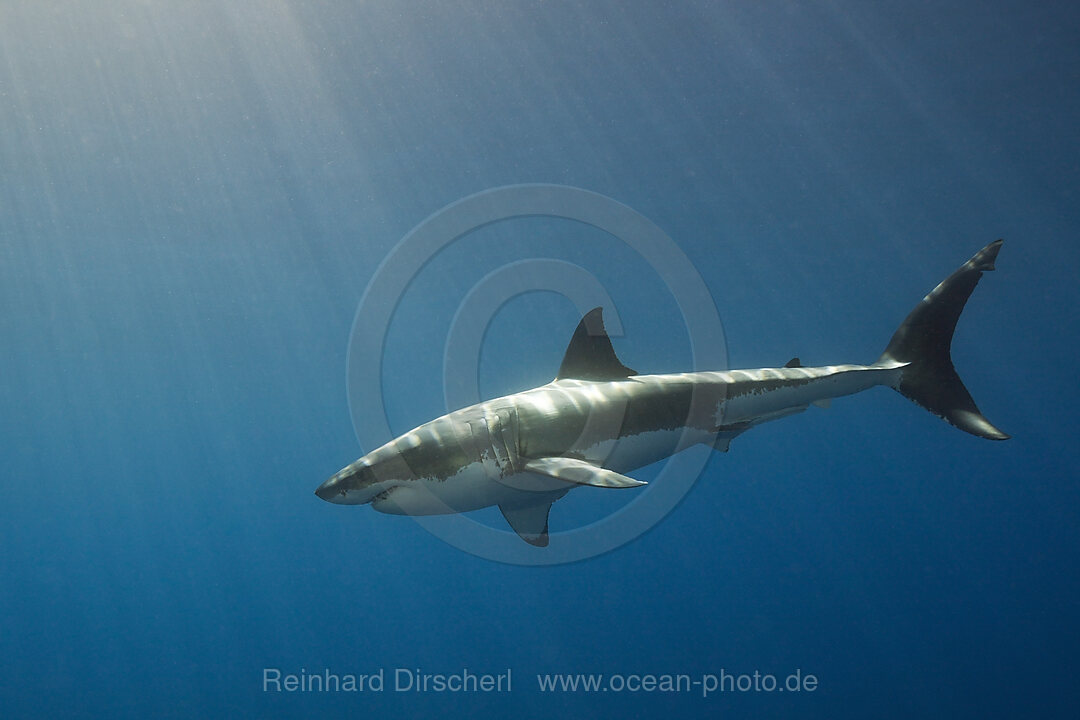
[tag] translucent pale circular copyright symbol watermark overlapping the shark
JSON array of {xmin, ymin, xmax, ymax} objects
[{"xmin": 347, "ymin": 185, "xmax": 727, "ymax": 566}]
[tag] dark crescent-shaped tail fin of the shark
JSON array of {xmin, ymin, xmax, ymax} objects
[{"xmin": 878, "ymin": 240, "xmax": 1009, "ymax": 440}]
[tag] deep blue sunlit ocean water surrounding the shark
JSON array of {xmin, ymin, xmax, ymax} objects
[{"xmin": 0, "ymin": 0, "xmax": 1080, "ymax": 718}]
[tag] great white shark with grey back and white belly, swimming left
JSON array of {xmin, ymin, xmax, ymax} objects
[{"xmin": 315, "ymin": 240, "xmax": 1009, "ymax": 546}]
